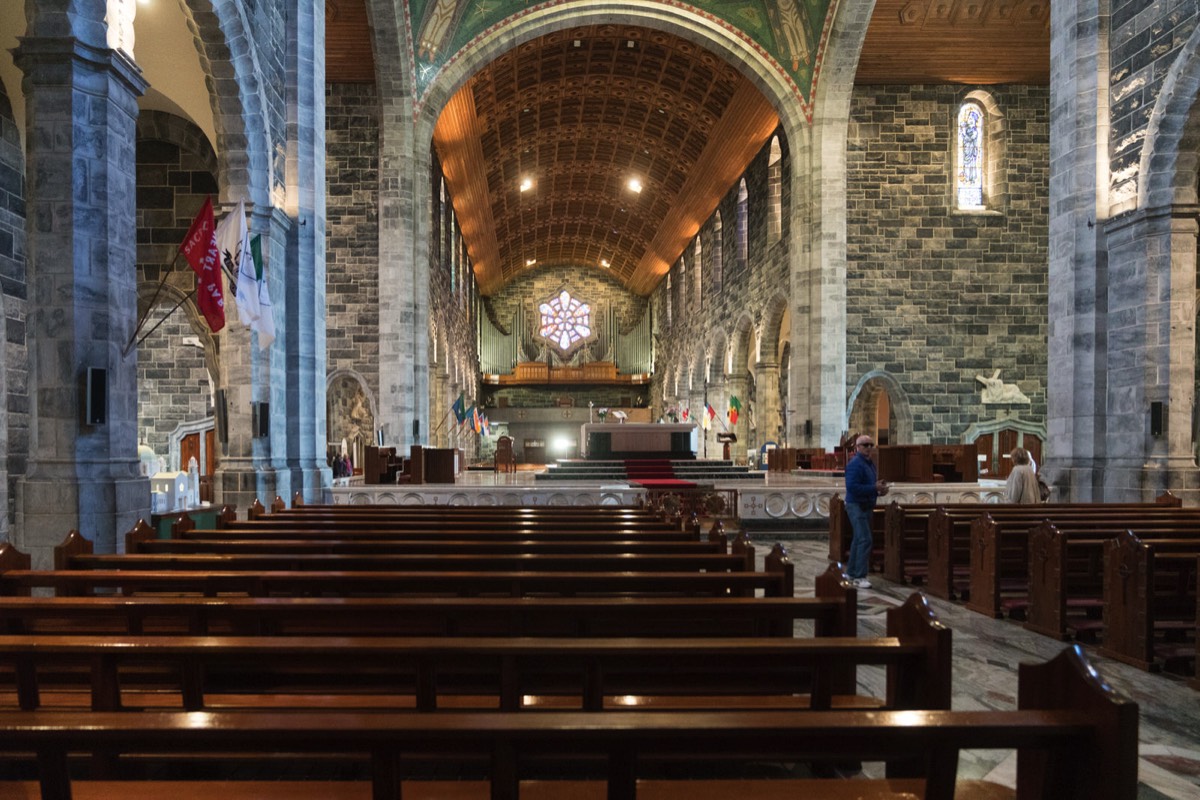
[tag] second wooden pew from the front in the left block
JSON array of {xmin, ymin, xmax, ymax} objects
[{"xmin": 0, "ymin": 594, "xmax": 950, "ymax": 711}]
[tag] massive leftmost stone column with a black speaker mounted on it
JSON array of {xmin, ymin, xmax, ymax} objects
[{"xmin": 14, "ymin": 17, "xmax": 150, "ymax": 569}]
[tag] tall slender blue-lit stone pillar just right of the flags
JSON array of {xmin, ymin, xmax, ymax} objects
[{"xmin": 272, "ymin": 0, "xmax": 332, "ymax": 503}]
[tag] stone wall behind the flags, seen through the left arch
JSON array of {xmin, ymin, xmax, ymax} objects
[{"xmin": 137, "ymin": 112, "xmax": 221, "ymax": 470}]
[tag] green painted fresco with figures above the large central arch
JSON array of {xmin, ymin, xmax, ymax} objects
[{"xmin": 408, "ymin": 0, "xmax": 832, "ymax": 106}]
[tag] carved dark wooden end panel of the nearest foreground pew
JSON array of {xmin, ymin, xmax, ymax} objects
[{"xmin": 1016, "ymin": 644, "xmax": 1138, "ymax": 800}]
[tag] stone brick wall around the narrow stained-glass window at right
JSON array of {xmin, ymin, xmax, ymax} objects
[{"xmin": 844, "ymin": 86, "xmax": 1049, "ymax": 443}]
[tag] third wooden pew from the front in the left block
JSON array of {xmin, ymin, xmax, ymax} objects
[{"xmin": 0, "ymin": 565, "xmax": 858, "ymax": 637}]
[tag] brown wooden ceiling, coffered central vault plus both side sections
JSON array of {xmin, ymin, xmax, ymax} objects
[{"xmin": 325, "ymin": 0, "xmax": 1050, "ymax": 294}]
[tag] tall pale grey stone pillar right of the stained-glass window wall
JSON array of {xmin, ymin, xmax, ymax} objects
[{"xmin": 1039, "ymin": 0, "xmax": 1115, "ymax": 501}]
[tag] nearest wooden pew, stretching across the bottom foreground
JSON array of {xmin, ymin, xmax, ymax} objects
[{"xmin": 0, "ymin": 649, "xmax": 1138, "ymax": 800}]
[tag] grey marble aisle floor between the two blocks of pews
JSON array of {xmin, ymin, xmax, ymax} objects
[{"xmin": 768, "ymin": 533, "xmax": 1200, "ymax": 800}]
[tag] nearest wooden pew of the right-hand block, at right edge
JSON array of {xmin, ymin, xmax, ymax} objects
[{"xmin": 1100, "ymin": 531, "xmax": 1200, "ymax": 669}]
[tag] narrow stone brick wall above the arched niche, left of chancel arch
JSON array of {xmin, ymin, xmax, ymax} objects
[{"xmin": 325, "ymin": 84, "xmax": 379, "ymax": 397}]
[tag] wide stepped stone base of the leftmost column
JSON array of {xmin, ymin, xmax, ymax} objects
[{"xmin": 13, "ymin": 476, "xmax": 150, "ymax": 570}]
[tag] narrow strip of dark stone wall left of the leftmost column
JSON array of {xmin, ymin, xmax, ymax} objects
[{"xmin": 0, "ymin": 86, "xmax": 29, "ymax": 520}]
